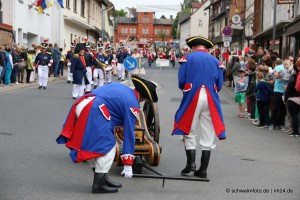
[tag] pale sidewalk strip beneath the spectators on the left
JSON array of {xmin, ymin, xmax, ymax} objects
[{"xmin": 0, "ymin": 73, "xmax": 67, "ymax": 94}]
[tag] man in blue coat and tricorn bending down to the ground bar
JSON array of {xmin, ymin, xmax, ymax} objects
[{"xmin": 56, "ymin": 77, "xmax": 158, "ymax": 193}]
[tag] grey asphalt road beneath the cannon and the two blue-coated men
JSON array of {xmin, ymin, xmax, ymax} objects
[{"xmin": 0, "ymin": 61, "xmax": 300, "ymax": 200}]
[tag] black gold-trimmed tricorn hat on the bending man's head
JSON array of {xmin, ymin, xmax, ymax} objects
[{"xmin": 132, "ymin": 76, "xmax": 158, "ymax": 102}]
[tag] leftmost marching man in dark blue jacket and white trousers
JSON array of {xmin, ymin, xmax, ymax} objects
[{"xmin": 34, "ymin": 40, "xmax": 53, "ymax": 89}]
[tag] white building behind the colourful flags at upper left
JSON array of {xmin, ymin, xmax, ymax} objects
[{"xmin": 13, "ymin": 0, "xmax": 63, "ymax": 48}]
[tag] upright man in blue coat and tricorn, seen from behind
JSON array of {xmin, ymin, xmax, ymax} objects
[{"xmin": 172, "ymin": 36, "xmax": 226, "ymax": 178}]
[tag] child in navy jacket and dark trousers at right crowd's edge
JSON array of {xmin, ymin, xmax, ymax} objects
[{"xmin": 254, "ymin": 72, "xmax": 272, "ymax": 128}]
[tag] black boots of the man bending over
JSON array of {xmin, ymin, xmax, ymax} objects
[{"xmin": 92, "ymin": 173, "xmax": 118, "ymax": 194}]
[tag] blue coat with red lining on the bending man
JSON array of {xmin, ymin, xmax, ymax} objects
[{"xmin": 56, "ymin": 83, "xmax": 139, "ymax": 162}]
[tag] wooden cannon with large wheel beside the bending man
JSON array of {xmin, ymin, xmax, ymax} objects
[{"xmin": 114, "ymin": 100, "xmax": 162, "ymax": 174}]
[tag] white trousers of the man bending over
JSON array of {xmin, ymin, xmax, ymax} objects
[{"xmin": 76, "ymin": 97, "xmax": 116, "ymax": 173}]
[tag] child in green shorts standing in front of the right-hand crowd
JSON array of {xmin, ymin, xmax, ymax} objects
[{"xmin": 234, "ymin": 68, "xmax": 248, "ymax": 118}]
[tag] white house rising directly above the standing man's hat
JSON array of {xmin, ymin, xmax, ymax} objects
[{"xmin": 190, "ymin": 0, "xmax": 210, "ymax": 38}]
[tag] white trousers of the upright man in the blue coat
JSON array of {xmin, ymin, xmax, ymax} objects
[{"xmin": 183, "ymin": 86, "xmax": 216, "ymax": 150}]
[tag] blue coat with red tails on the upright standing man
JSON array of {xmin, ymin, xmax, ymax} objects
[{"xmin": 172, "ymin": 51, "xmax": 226, "ymax": 139}]
